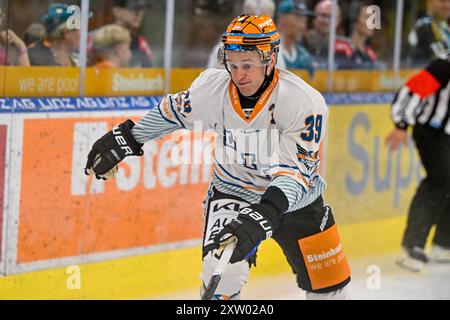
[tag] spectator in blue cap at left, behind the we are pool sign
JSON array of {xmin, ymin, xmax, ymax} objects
[{"xmin": 28, "ymin": 3, "xmax": 80, "ymax": 67}]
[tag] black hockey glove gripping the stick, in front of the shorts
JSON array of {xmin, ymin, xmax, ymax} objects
[{"xmin": 211, "ymin": 204, "xmax": 278, "ymax": 263}]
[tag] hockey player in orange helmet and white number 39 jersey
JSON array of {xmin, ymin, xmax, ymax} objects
[{"xmin": 86, "ymin": 15, "xmax": 350, "ymax": 299}]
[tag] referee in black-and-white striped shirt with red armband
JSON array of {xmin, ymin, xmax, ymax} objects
[{"xmin": 386, "ymin": 53, "xmax": 450, "ymax": 272}]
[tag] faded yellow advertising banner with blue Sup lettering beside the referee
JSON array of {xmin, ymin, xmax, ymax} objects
[{"xmin": 325, "ymin": 104, "xmax": 423, "ymax": 223}]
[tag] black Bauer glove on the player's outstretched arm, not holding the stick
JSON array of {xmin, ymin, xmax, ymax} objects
[{"xmin": 84, "ymin": 120, "xmax": 144, "ymax": 180}]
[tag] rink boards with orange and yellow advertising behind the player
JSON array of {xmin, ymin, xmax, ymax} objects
[{"xmin": 0, "ymin": 98, "xmax": 421, "ymax": 299}]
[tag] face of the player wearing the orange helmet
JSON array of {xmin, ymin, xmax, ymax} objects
[{"xmin": 227, "ymin": 52, "xmax": 266, "ymax": 96}]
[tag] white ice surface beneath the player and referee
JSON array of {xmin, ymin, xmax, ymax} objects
[{"xmin": 151, "ymin": 254, "xmax": 450, "ymax": 300}]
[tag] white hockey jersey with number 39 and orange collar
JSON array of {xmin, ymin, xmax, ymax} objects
[{"xmin": 132, "ymin": 69, "xmax": 328, "ymax": 211}]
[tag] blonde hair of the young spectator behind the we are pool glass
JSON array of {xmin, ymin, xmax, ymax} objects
[{"xmin": 92, "ymin": 24, "xmax": 131, "ymax": 51}]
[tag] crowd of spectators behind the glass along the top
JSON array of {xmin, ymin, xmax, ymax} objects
[{"xmin": 0, "ymin": 0, "xmax": 450, "ymax": 70}]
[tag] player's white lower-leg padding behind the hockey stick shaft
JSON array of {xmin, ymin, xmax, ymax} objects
[{"xmin": 200, "ymin": 253, "xmax": 250, "ymax": 300}]
